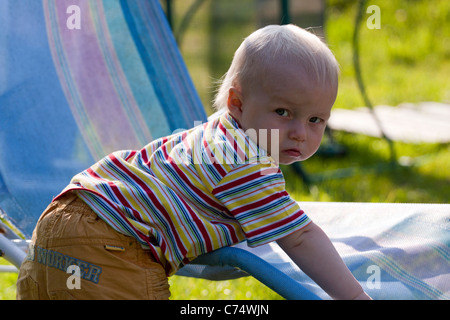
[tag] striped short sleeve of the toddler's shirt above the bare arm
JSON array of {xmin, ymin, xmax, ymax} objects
[{"xmin": 213, "ymin": 162, "xmax": 311, "ymax": 247}]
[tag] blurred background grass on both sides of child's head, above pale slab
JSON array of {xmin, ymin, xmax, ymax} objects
[{"xmin": 175, "ymin": 0, "xmax": 450, "ymax": 111}]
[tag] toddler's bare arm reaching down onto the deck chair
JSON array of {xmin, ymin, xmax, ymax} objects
[{"xmin": 277, "ymin": 222, "xmax": 370, "ymax": 300}]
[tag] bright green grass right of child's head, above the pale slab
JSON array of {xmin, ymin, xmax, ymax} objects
[{"xmin": 327, "ymin": 0, "xmax": 450, "ymax": 108}]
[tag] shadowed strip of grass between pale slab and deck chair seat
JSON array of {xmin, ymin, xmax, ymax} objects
[{"xmin": 282, "ymin": 133, "xmax": 450, "ymax": 203}]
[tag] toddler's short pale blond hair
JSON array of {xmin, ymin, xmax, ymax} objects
[{"xmin": 213, "ymin": 24, "xmax": 339, "ymax": 110}]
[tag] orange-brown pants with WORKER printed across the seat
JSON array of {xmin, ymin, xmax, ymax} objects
[{"xmin": 17, "ymin": 193, "xmax": 170, "ymax": 300}]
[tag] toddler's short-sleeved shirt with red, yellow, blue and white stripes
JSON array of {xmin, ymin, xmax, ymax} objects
[{"xmin": 61, "ymin": 113, "xmax": 310, "ymax": 275}]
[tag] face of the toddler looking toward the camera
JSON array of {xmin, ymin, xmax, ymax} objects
[{"xmin": 228, "ymin": 63, "xmax": 336, "ymax": 164}]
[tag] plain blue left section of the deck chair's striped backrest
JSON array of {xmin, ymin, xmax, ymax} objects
[{"xmin": 0, "ymin": 1, "xmax": 89, "ymax": 235}]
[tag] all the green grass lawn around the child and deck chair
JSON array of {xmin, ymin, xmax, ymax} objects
[{"xmin": 0, "ymin": 0, "xmax": 450, "ymax": 299}]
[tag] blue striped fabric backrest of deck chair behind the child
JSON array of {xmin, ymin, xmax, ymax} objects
[{"xmin": 0, "ymin": 0, "xmax": 206, "ymax": 236}]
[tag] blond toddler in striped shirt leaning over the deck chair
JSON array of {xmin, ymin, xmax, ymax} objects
[{"xmin": 17, "ymin": 25, "xmax": 369, "ymax": 299}]
